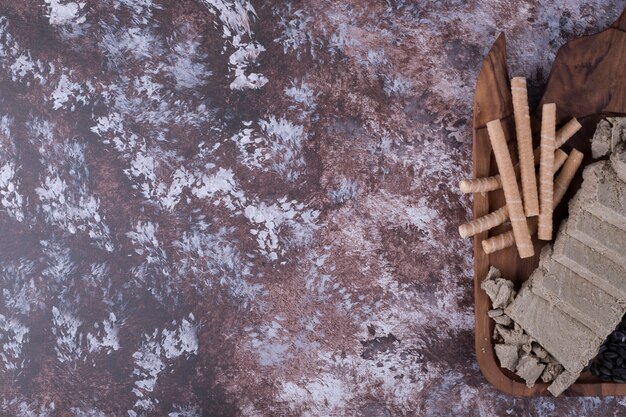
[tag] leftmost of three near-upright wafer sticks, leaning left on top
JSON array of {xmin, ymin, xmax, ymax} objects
[{"xmin": 487, "ymin": 120, "xmax": 535, "ymax": 259}]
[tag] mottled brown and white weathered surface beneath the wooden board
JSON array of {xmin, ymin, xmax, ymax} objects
[{"xmin": 0, "ymin": 0, "xmax": 626, "ymax": 417}]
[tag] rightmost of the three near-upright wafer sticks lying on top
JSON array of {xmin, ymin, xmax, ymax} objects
[{"xmin": 537, "ymin": 103, "xmax": 556, "ymax": 240}]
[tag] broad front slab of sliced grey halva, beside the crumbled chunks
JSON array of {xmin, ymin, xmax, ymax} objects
[{"xmin": 504, "ymin": 287, "xmax": 603, "ymax": 372}]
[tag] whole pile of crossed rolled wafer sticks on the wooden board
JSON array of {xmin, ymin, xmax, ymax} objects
[{"xmin": 459, "ymin": 77, "xmax": 583, "ymax": 258}]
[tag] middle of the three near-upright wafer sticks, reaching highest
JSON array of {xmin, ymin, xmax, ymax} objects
[{"xmin": 511, "ymin": 77, "xmax": 539, "ymax": 216}]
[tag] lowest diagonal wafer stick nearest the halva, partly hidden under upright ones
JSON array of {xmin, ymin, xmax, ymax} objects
[{"xmin": 481, "ymin": 149, "xmax": 583, "ymax": 254}]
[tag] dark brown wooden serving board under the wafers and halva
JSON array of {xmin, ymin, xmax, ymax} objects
[{"xmin": 473, "ymin": 10, "xmax": 626, "ymax": 396}]
